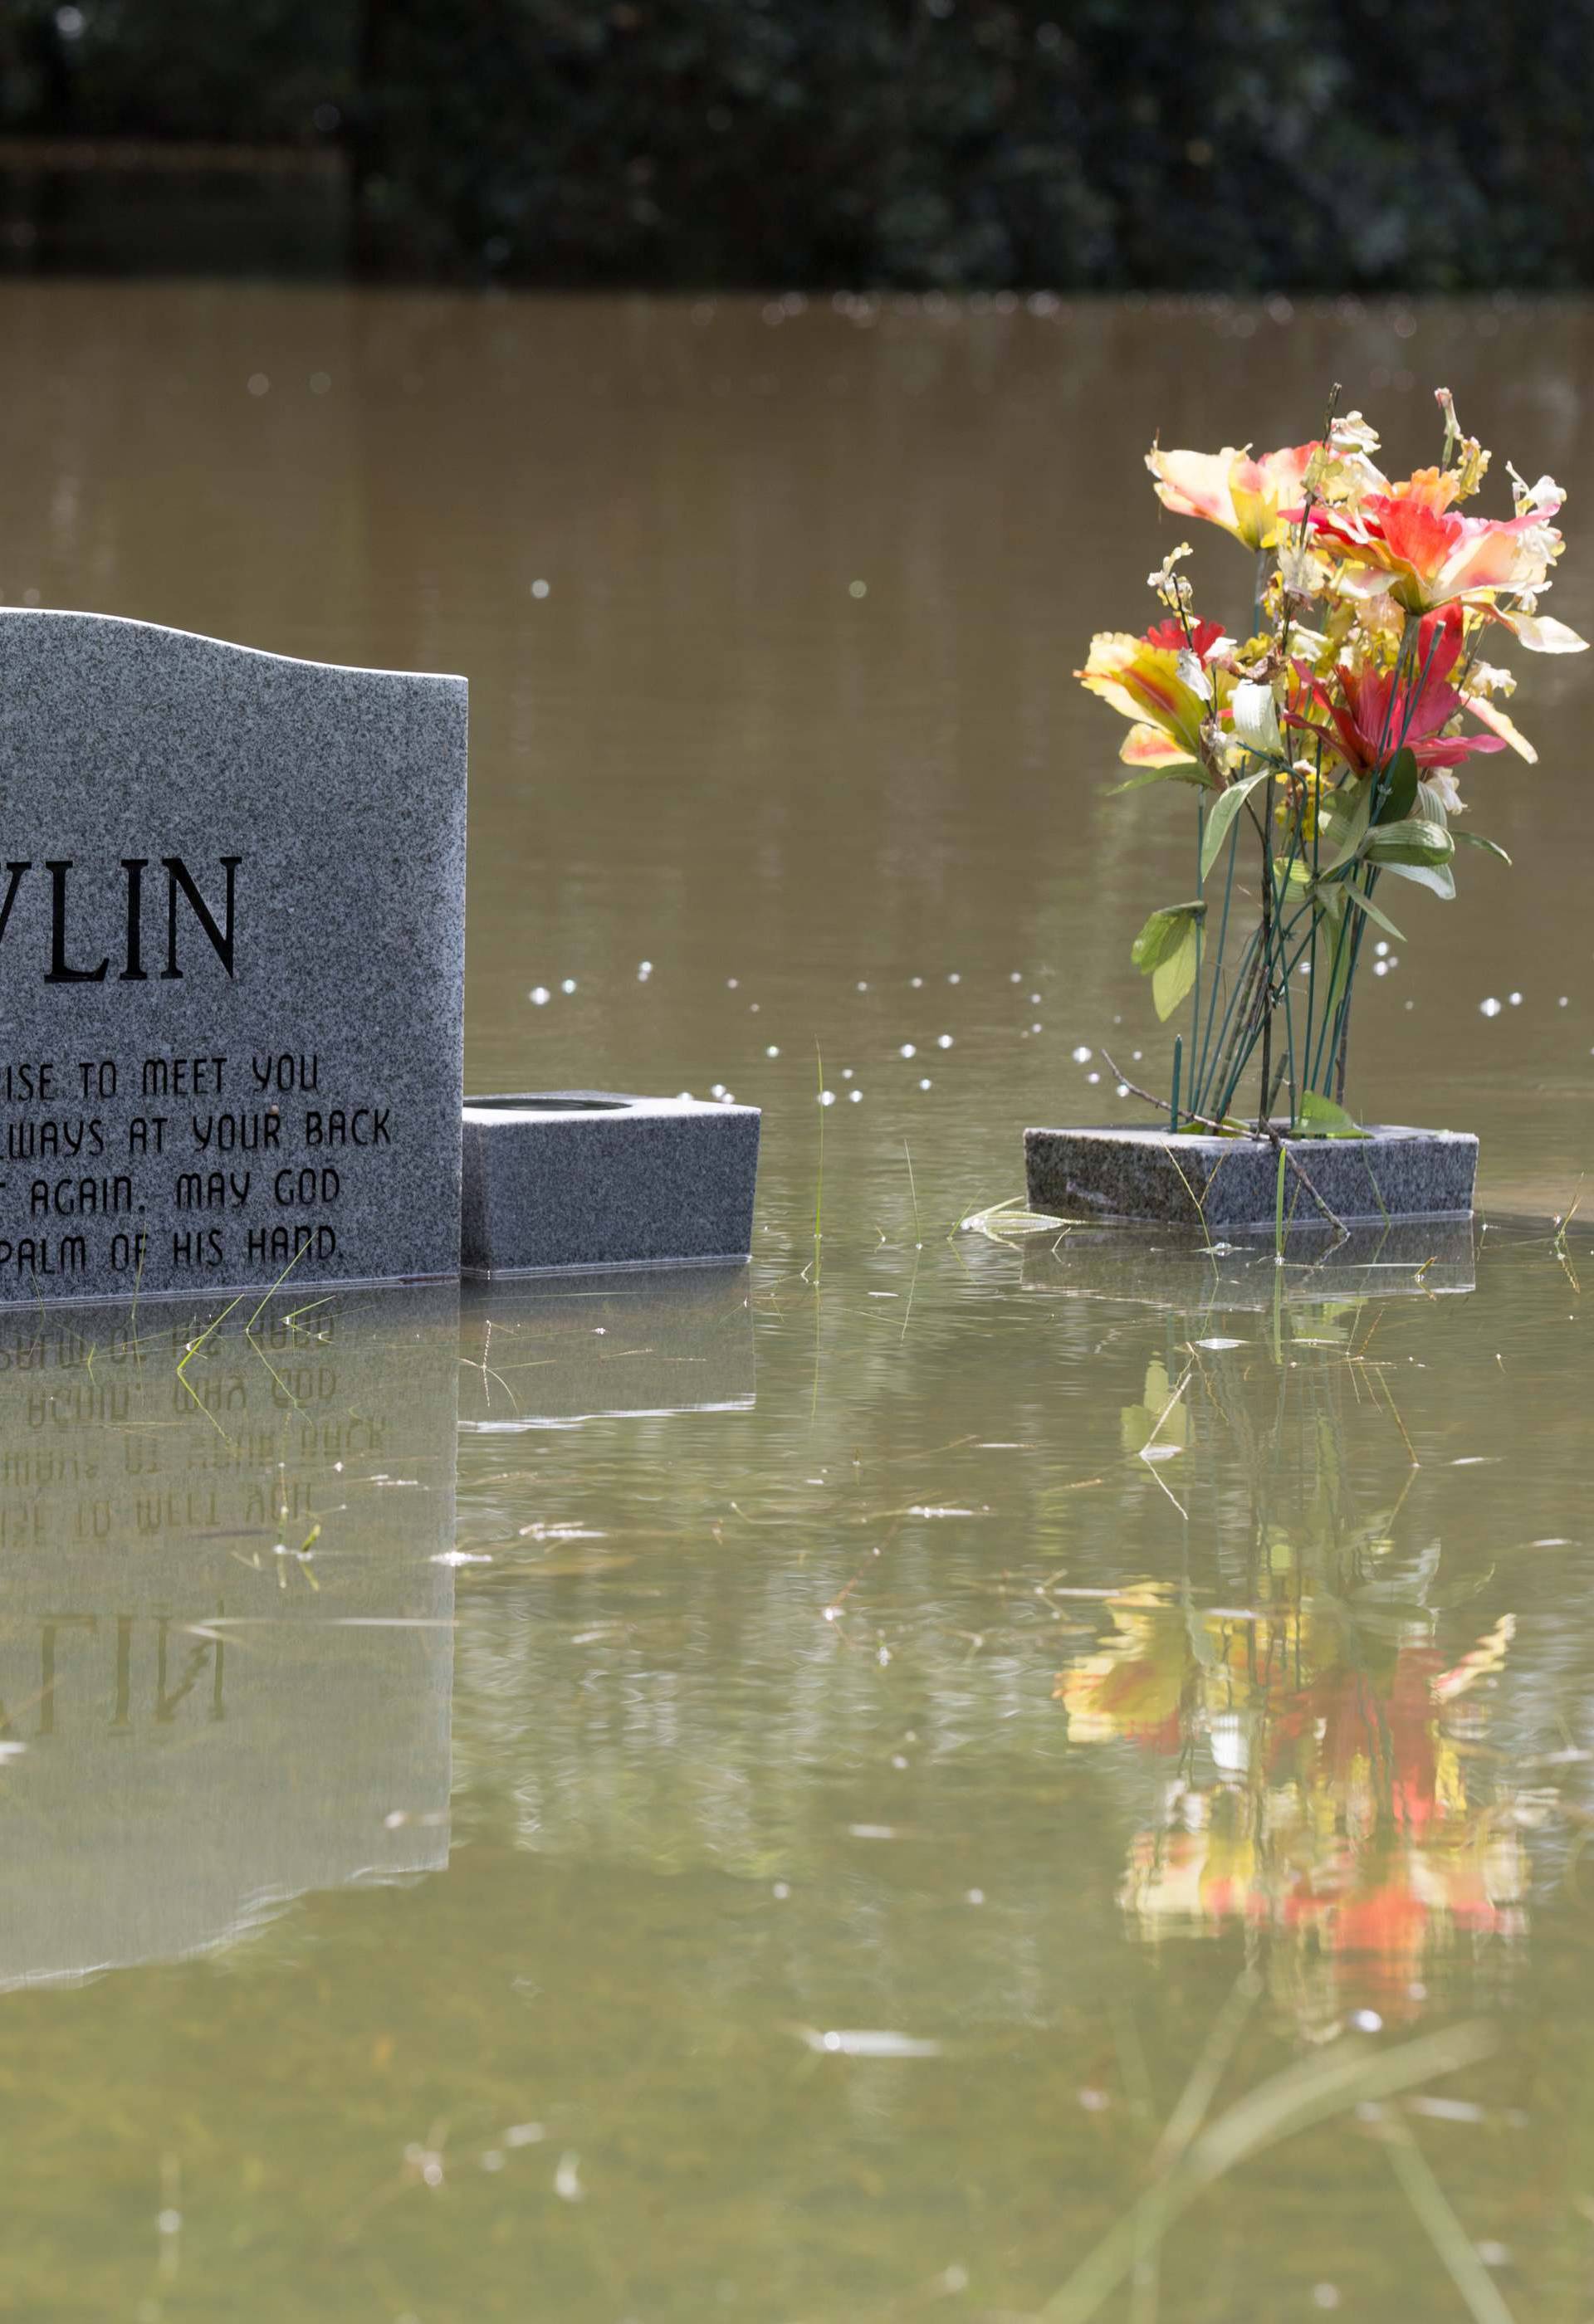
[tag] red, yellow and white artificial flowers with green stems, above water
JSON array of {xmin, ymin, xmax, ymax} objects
[{"xmin": 1078, "ymin": 388, "xmax": 1585, "ymax": 1141}]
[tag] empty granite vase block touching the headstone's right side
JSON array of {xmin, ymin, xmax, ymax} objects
[{"xmin": 460, "ymin": 1090, "xmax": 760, "ymax": 1276}]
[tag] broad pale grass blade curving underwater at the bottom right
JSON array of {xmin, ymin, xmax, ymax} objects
[{"xmin": 1039, "ymin": 2022, "xmax": 1496, "ymax": 2324}]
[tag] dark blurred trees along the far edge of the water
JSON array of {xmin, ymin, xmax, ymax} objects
[{"xmin": 0, "ymin": 0, "xmax": 1594, "ymax": 290}]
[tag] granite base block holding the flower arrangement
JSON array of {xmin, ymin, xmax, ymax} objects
[{"xmin": 1024, "ymin": 1122, "xmax": 1478, "ymax": 1234}]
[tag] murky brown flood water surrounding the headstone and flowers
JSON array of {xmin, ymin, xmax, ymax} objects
[{"xmin": 0, "ymin": 284, "xmax": 1594, "ymax": 2324}]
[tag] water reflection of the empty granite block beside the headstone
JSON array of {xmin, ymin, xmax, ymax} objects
[{"xmin": 460, "ymin": 1267, "xmax": 753, "ymax": 1434}]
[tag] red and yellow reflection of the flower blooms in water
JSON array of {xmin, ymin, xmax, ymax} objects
[{"xmin": 1057, "ymin": 1583, "xmax": 1527, "ymax": 1996}]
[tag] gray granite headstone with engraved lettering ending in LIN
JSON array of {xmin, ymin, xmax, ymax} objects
[{"xmin": 0, "ymin": 609, "xmax": 465, "ymax": 1301}]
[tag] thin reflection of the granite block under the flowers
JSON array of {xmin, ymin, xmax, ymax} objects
[{"xmin": 1022, "ymin": 1218, "xmax": 1475, "ymax": 1311}]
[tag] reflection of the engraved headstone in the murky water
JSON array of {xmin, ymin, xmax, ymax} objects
[{"xmin": 0, "ymin": 1285, "xmax": 457, "ymax": 1987}]
